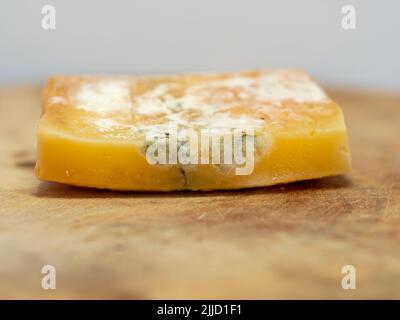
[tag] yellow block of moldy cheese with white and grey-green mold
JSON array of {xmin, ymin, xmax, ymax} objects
[{"xmin": 35, "ymin": 70, "xmax": 350, "ymax": 191}]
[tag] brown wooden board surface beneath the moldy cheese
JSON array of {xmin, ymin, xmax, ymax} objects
[{"xmin": 0, "ymin": 87, "xmax": 400, "ymax": 299}]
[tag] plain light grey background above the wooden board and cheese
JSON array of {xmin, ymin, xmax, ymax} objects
[{"xmin": 0, "ymin": 0, "xmax": 400, "ymax": 90}]
